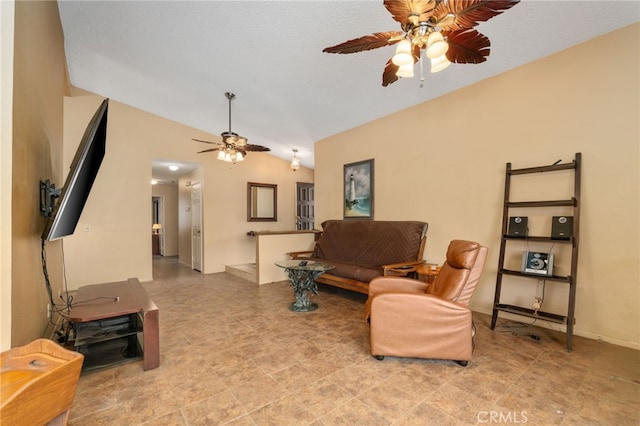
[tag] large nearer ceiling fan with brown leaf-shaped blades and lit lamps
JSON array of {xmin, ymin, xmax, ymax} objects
[{"xmin": 323, "ymin": 0, "xmax": 519, "ymax": 87}]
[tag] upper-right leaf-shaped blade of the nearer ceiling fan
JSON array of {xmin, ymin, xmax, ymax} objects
[{"xmin": 433, "ymin": 0, "xmax": 519, "ymax": 30}]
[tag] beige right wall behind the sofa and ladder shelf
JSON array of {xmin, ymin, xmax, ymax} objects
[{"xmin": 315, "ymin": 24, "xmax": 640, "ymax": 348}]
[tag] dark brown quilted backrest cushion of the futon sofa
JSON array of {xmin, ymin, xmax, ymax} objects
[{"xmin": 313, "ymin": 220, "xmax": 427, "ymax": 266}]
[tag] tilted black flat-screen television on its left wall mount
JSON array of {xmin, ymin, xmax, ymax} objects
[{"xmin": 40, "ymin": 99, "xmax": 109, "ymax": 241}]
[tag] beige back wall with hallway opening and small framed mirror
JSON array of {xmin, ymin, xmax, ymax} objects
[{"xmin": 64, "ymin": 90, "xmax": 313, "ymax": 288}]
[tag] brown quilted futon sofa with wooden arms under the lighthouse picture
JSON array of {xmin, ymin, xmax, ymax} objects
[{"xmin": 289, "ymin": 220, "xmax": 428, "ymax": 294}]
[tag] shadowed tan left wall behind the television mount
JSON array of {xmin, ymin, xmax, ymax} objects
[{"xmin": 9, "ymin": 1, "xmax": 66, "ymax": 346}]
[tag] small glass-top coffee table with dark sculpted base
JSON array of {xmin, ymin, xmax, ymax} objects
[{"xmin": 276, "ymin": 260, "xmax": 335, "ymax": 312}]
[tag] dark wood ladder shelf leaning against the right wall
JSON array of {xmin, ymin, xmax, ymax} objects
[{"xmin": 491, "ymin": 153, "xmax": 582, "ymax": 352}]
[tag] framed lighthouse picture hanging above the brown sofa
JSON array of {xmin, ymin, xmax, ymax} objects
[{"xmin": 343, "ymin": 159, "xmax": 373, "ymax": 219}]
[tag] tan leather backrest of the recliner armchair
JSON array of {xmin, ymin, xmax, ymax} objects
[{"xmin": 426, "ymin": 240, "xmax": 487, "ymax": 305}]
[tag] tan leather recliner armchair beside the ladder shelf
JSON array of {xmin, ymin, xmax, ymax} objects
[{"xmin": 366, "ymin": 240, "xmax": 487, "ymax": 366}]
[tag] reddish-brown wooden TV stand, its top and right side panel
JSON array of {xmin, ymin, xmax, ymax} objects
[{"xmin": 69, "ymin": 278, "xmax": 160, "ymax": 370}]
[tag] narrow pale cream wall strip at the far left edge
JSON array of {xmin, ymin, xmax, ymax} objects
[{"xmin": 0, "ymin": 1, "xmax": 15, "ymax": 351}]
